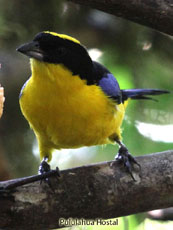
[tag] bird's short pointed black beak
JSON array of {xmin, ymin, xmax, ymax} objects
[{"xmin": 16, "ymin": 41, "xmax": 44, "ymax": 61}]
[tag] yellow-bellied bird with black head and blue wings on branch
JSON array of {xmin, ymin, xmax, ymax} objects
[{"xmin": 17, "ymin": 31, "xmax": 169, "ymax": 179}]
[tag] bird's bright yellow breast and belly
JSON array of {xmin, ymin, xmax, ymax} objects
[{"xmin": 20, "ymin": 60, "xmax": 124, "ymax": 160}]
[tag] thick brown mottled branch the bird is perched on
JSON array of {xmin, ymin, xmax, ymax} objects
[{"xmin": 0, "ymin": 150, "xmax": 173, "ymax": 230}]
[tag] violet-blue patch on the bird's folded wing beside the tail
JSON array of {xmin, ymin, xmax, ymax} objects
[{"xmin": 98, "ymin": 73, "xmax": 122, "ymax": 103}]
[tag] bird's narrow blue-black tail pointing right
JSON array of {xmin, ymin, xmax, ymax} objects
[{"xmin": 121, "ymin": 89, "xmax": 170, "ymax": 102}]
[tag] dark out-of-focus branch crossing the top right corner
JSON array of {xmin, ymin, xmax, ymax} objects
[{"xmin": 68, "ymin": 0, "xmax": 173, "ymax": 35}]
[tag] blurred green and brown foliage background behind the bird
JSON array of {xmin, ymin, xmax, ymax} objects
[{"xmin": 0, "ymin": 0, "xmax": 173, "ymax": 229}]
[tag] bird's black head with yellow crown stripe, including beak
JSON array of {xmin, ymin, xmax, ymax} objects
[{"xmin": 17, "ymin": 32, "xmax": 92, "ymax": 83}]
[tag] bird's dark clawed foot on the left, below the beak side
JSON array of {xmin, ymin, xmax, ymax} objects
[{"xmin": 38, "ymin": 157, "xmax": 60, "ymax": 190}]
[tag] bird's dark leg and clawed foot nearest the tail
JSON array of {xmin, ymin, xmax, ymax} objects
[{"xmin": 115, "ymin": 140, "xmax": 141, "ymax": 181}]
